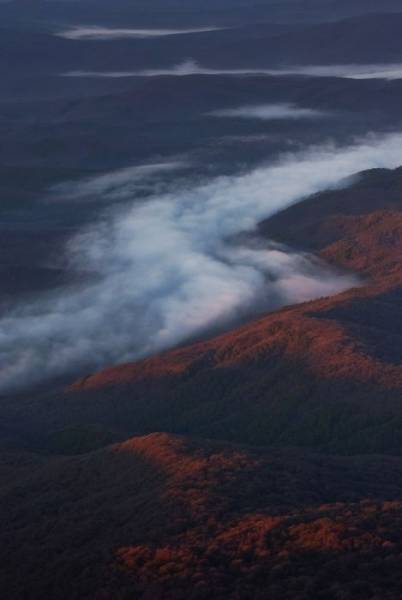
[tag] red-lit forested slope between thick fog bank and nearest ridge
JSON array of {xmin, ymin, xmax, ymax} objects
[{"xmin": 1, "ymin": 169, "xmax": 402, "ymax": 453}]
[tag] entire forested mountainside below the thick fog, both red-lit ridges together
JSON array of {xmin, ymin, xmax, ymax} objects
[{"xmin": 0, "ymin": 169, "xmax": 402, "ymax": 600}]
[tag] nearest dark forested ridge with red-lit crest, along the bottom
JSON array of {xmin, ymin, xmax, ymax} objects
[{"xmin": 0, "ymin": 434, "xmax": 402, "ymax": 600}]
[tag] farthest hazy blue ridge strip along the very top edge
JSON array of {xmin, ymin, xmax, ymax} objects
[{"xmin": 3, "ymin": 0, "xmax": 401, "ymax": 26}]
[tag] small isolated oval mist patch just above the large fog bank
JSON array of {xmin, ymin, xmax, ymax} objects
[{"xmin": 209, "ymin": 104, "xmax": 327, "ymax": 121}]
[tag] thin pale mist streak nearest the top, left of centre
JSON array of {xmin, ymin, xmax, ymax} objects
[{"xmin": 55, "ymin": 25, "xmax": 220, "ymax": 40}]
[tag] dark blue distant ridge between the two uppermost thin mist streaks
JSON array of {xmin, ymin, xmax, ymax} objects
[{"xmin": 5, "ymin": 13, "xmax": 402, "ymax": 75}]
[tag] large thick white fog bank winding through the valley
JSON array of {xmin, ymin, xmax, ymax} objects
[{"xmin": 0, "ymin": 135, "xmax": 402, "ymax": 392}]
